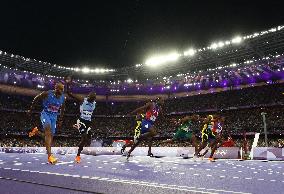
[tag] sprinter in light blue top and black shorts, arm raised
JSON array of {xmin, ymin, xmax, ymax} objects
[{"xmin": 67, "ymin": 79, "xmax": 96, "ymax": 163}]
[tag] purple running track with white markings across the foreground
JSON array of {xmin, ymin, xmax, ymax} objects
[{"xmin": 0, "ymin": 153, "xmax": 284, "ymax": 194}]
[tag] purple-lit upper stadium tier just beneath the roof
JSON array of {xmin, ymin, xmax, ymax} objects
[{"xmin": 0, "ymin": 55, "xmax": 284, "ymax": 95}]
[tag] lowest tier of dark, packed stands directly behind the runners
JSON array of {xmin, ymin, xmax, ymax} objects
[{"xmin": 0, "ymin": 105, "xmax": 284, "ymax": 138}]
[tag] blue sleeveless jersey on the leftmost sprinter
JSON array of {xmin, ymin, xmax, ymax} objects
[{"xmin": 43, "ymin": 90, "xmax": 65, "ymax": 116}]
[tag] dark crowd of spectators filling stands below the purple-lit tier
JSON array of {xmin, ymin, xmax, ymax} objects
[{"xmin": 0, "ymin": 81, "xmax": 284, "ymax": 145}]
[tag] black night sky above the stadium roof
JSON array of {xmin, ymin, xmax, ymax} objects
[{"xmin": 0, "ymin": 0, "xmax": 284, "ymax": 68}]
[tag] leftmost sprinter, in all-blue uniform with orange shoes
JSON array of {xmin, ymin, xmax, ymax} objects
[{"xmin": 28, "ymin": 83, "xmax": 65, "ymax": 164}]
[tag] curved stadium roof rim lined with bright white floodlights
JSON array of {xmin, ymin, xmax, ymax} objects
[{"xmin": 0, "ymin": 26, "xmax": 284, "ymax": 80}]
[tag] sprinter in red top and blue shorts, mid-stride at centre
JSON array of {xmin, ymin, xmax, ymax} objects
[{"xmin": 127, "ymin": 98, "xmax": 164, "ymax": 159}]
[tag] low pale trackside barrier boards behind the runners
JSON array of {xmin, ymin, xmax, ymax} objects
[{"xmin": 0, "ymin": 147, "xmax": 240, "ymax": 159}]
